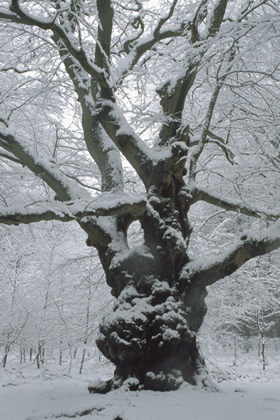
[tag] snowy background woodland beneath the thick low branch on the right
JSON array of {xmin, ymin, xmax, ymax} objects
[{"xmin": 200, "ymin": 253, "xmax": 279, "ymax": 362}]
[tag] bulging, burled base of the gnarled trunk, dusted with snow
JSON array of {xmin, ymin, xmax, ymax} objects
[{"xmin": 90, "ymin": 277, "xmax": 212, "ymax": 393}]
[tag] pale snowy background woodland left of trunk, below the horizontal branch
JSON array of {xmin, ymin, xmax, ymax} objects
[{"xmin": 0, "ymin": 222, "xmax": 109, "ymax": 370}]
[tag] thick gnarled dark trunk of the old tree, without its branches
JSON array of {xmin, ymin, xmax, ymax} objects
[{"xmin": 90, "ymin": 184, "xmax": 207, "ymax": 392}]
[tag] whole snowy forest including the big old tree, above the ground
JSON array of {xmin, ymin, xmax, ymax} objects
[{"xmin": 0, "ymin": 0, "xmax": 280, "ymax": 394}]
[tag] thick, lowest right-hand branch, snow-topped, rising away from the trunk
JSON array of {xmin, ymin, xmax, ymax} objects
[{"xmin": 181, "ymin": 220, "xmax": 280, "ymax": 286}]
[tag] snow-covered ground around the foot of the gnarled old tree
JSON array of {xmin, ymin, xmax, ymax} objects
[{"xmin": 0, "ymin": 357, "xmax": 280, "ymax": 420}]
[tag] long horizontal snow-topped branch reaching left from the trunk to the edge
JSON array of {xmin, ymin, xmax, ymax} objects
[{"xmin": 0, "ymin": 193, "xmax": 146, "ymax": 225}]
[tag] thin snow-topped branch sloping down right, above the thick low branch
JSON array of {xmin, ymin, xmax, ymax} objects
[{"xmin": 193, "ymin": 188, "xmax": 280, "ymax": 220}]
